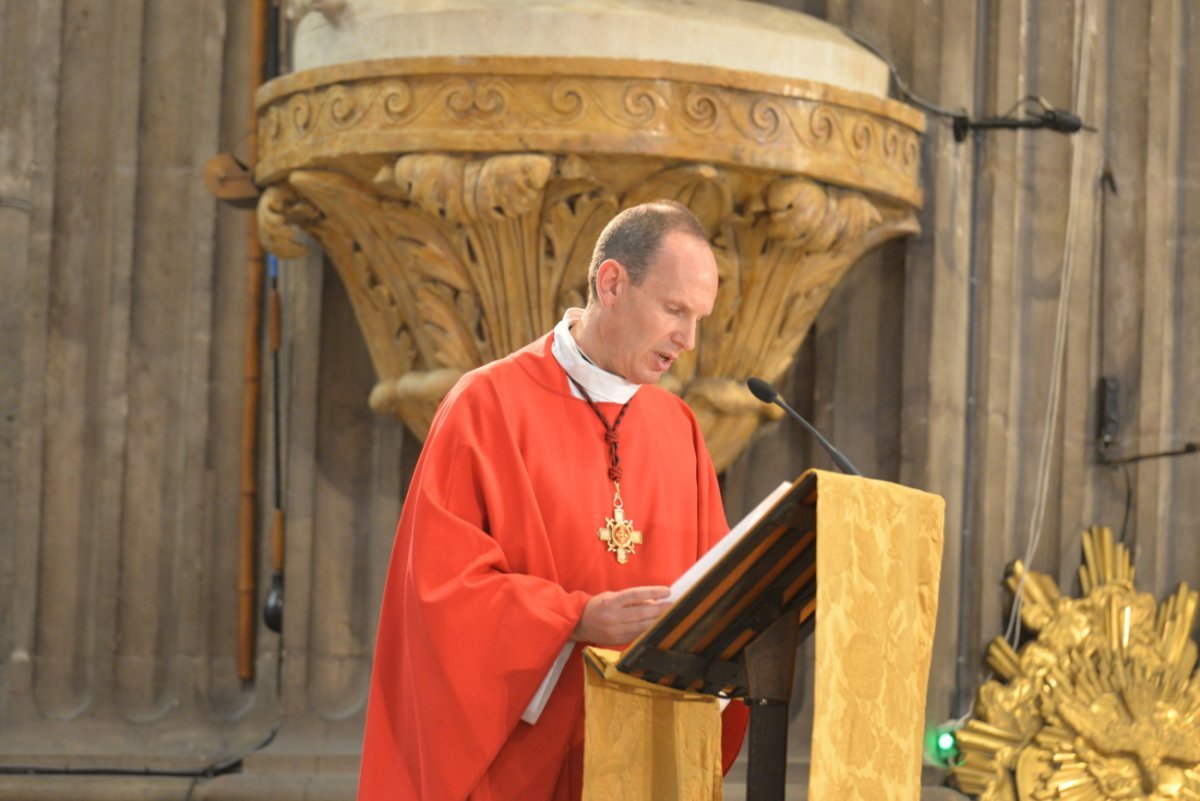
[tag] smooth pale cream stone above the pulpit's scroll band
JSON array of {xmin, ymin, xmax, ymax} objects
[{"xmin": 293, "ymin": 0, "xmax": 888, "ymax": 96}]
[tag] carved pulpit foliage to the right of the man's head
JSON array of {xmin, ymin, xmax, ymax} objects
[{"xmin": 643, "ymin": 165, "xmax": 917, "ymax": 470}]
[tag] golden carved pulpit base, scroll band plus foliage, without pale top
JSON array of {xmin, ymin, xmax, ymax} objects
[{"xmin": 257, "ymin": 59, "xmax": 920, "ymax": 470}]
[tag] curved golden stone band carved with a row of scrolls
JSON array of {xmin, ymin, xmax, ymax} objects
[{"xmin": 256, "ymin": 56, "xmax": 924, "ymax": 209}]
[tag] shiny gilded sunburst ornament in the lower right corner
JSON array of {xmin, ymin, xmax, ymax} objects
[{"xmin": 954, "ymin": 528, "xmax": 1200, "ymax": 801}]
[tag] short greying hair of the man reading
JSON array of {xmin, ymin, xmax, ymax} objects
[{"xmin": 588, "ymin": 200, "xmax": 708, "ymax": 301}]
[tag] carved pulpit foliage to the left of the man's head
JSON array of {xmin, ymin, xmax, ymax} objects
[{"xmin": 259, "ymin": 149, "xmax": 617, "ymax": 436}]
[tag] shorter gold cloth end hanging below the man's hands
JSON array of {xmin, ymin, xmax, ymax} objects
[{"xmin": 583, "ymin": 648, "xmax": 721, "ymax": 801}]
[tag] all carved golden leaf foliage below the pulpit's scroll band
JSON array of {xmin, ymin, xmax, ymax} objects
[{"xmin": 259, "ymin": 153, "xmax": 916, "ymax": 469}]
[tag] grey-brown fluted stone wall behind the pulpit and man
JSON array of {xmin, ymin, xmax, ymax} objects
[{"xmin": 0, "ymin": 0, "xmax": 1200, "ymax": 799}]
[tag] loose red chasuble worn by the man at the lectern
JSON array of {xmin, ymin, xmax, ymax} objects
[{"xmin": 359, "ymin": 335, "xmax": 745, "ymax": 801}]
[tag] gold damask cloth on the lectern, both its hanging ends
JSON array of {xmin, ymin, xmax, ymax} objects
[{"xmin": 583, "ymin": 471, "xmax": 946, "ymax": 801}]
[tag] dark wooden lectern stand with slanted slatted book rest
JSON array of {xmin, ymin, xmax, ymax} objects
[{"xmin": 617, "ymin": 471, "xmax": 817, "ymax": 801}]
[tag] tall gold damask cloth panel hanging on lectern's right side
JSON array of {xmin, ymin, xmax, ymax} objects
[{"xmin": 808, "ymin": 471, "xmax": 946, "ymax": 801}]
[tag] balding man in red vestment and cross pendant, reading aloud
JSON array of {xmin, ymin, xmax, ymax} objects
[{"xmin": 359, "ymin": 201, "xmax": 745, "ymax": 801}]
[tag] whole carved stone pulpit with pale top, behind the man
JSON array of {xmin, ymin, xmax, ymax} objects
[{"xmin": 254, "ymin": 0, "xmax": 923, "ymax": 470}]
